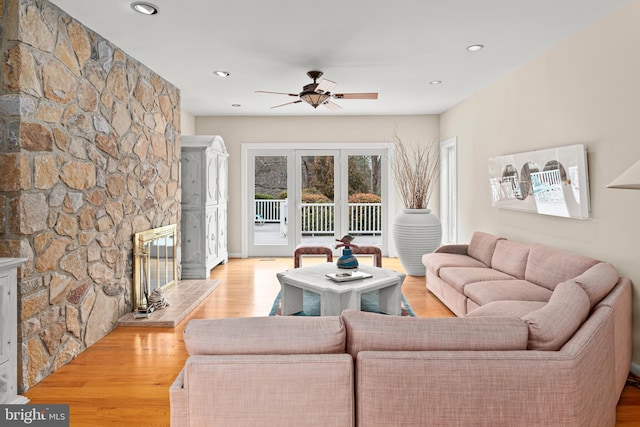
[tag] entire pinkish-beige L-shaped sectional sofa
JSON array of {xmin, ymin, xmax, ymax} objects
[{"xmin": 170, "ymin": 234, "xmax": 631, "ymax": 427}]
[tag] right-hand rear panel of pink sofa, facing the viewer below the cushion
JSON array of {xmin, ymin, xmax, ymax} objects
[{"xmin": 356, "ymin": 310, "xmax": 618, "ymax": 426}]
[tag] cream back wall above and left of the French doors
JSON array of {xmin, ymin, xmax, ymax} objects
[{"xmin": 196, "ymin": 114, "xmax": 439, "ymax": 256}]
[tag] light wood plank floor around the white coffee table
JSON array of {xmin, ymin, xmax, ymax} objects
[{"xmin": 25, "ymin": 258, "xmax": 640, "ymax": 427}]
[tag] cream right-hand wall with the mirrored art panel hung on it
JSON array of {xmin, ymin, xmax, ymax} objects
[{"xmin": 440, "ymin": 0, "xmax": 640, "ymax": 368}]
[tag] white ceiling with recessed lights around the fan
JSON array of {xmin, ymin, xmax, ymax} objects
[{"xmin": 52, "ymin": 0, "xmax": 628, "ymax": 116}]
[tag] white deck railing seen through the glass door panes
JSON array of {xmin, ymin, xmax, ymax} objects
[{"xmin": 255, "ymin": 200, "xmax": 382, "ymax": 235}]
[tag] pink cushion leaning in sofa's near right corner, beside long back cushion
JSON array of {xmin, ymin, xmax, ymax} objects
[{"xmin": 522, "ymin": 281, "xmax": 590, "ymax": 351}]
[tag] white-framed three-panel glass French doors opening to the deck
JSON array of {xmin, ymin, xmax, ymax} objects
[{"xmin": 243, "ymin": 144, "xmax": 390, "ymax": 256}]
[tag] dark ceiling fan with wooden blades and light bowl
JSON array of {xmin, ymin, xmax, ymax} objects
[{"xmin": 256, "ymin": 71, "xmax": 378, "ymax": 110}]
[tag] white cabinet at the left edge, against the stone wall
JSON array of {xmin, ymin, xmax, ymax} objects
[{"xmin": 0, "ymin": 258, "xmax": 29, "ymax": 405}]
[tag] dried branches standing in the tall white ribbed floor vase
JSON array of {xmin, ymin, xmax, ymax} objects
[{"xmin": 393, "ymin": 134, "xmax": 440, "ymax": 209}]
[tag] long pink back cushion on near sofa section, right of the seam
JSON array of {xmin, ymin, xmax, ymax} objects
[{"xmin": 342, "ymin": 310, "xmax": 528, "ymax": 358}]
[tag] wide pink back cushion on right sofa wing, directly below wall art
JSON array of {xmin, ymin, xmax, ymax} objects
[{"xmin": 524, "ymin": 244, "xmax": 600, "ymax": 290}]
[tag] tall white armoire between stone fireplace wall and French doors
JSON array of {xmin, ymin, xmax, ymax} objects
[{"xmin": 180, "ymin": 136, "xmax": 229, "ymax": 279}]
